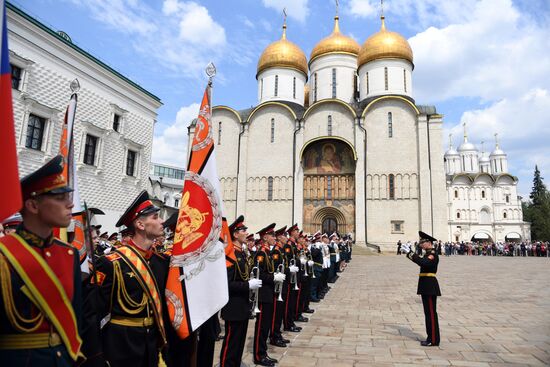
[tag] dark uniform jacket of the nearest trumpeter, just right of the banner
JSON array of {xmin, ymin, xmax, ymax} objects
[{"xmin": 222, "ymin": 247, "xmax": 251, "ymax": 321}]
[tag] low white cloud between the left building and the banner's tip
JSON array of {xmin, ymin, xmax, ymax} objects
[{"xmin": 152, "ymin": 103, "xmax": 200, "ymax": 167}]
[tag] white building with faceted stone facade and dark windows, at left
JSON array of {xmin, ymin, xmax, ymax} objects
[{"xmin": 7, "ymin": 3, "xmax": 161, "ymax": 231}]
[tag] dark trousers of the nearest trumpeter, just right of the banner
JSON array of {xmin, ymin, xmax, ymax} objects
[{"xmin": 220, "ymin": 319, "xmax": 248, "ymax": 367}]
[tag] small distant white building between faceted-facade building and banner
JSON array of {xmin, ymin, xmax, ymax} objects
[{"xmin": 147, "ymin": 163, "xmax": 185, "ymax": 219}]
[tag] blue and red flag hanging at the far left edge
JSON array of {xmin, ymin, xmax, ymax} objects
[{"xmin": 0, "ymin": 0, "xmax": 23, "ymax": 221}]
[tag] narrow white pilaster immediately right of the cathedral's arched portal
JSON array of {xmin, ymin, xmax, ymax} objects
[{"xmin": 354, "ymin": 117, "xmax": 367, "ymax": 245}]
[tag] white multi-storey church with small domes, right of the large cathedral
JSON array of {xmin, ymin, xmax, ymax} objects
[{"xmin": 445, "ymin": 127, "xmax": 531, "ymax": 242}]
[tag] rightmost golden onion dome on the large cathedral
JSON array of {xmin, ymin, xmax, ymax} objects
[{"xmin": 357, "ymin": 16, "xmax": 413, "ymax": 67}]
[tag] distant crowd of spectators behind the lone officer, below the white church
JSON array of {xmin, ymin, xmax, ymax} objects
[{"xmin": 397, "ymin": 241, "xmax": 550, "ymax": 257}]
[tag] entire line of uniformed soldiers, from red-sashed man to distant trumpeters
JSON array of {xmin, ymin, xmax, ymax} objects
[{"xmin": 0, "ymin": 156, "xmax": 351, "ymax": 367}]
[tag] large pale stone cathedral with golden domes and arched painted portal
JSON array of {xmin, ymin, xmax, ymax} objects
[{"xmin": 189, "ymin": 12, "xmax": 532, "ymax": 250}]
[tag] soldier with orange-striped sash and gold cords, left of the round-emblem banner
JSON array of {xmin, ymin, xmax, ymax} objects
[{"xmin": 94, "ymin": 190, "xmax": 169, "ymax": 367}]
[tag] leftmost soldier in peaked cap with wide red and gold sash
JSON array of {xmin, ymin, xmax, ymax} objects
[{"xmin": 0, "ymin": 156, "xmax": 82, "ymax": 366}]
